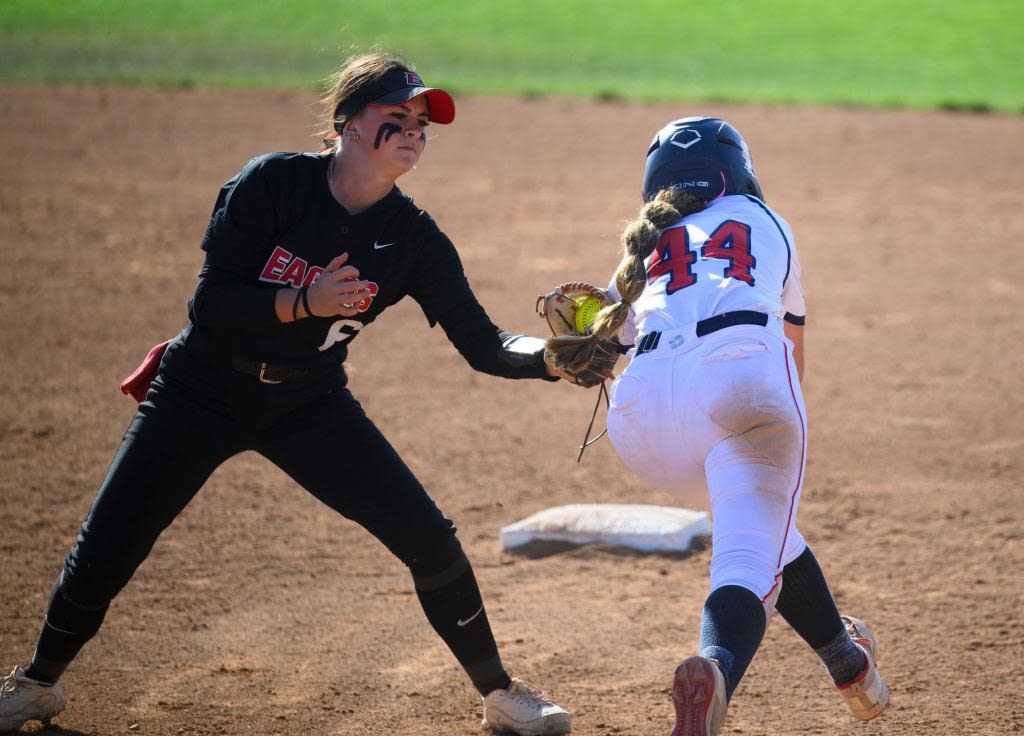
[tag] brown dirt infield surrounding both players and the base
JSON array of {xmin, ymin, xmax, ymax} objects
[{"xmin": 0, "ymin": 86, "xmax": 1024, "ymax": 736}]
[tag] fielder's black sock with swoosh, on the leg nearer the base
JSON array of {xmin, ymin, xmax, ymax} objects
[{"xmin": 413, "ymin": 554, "xmax": 511, "ymax": 695}]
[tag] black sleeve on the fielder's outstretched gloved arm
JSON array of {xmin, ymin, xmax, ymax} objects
[{"xmin": 409, "ymin": 222, "xmax": 558, "ymax": 381}]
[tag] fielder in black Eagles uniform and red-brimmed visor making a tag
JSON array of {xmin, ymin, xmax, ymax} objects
[{"xmin": 0, "ymin": 54, "xmax": 569, "ymax": 734}]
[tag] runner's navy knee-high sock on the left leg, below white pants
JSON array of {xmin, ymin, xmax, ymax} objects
[{"xmin": 700, "ymin": 586, "xmax": 766, "ymax": 699}]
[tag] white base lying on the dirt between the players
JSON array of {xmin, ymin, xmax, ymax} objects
[{"xmin": 500, "ymin": 504, "xmax": 711, "ymax": 552}]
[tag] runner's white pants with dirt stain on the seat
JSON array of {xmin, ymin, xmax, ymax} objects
[{"xmin": 608, "ymin": 319, "xmax": 807, "ymax": 611}]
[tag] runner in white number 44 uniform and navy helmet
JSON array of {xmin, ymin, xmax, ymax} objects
[{"xmin": 554, "ymin": 118, "xmax": 889, "ymax": 736}]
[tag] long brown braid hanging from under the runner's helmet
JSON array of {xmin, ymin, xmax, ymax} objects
[{"xmin": 546, "ymin": 189, "xmax": 707, "ymax": 373}]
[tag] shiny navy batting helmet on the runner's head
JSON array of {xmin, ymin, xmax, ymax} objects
[{"xmin": 643, "ymin": 118, "xmax": 764, "ymax": 202}]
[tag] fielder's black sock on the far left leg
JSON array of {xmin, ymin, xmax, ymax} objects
[{"xmin": 25, "ymin": 574, "xmax": 110, "ymax": 685}]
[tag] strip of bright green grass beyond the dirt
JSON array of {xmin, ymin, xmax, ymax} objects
[{"xmin": 0, "ymin": 0, "xmax": 1024, "ymax": 112}]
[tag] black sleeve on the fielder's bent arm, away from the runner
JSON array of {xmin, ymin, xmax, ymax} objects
[{"xmin": 190, "ymin": 157, "xmax": 281, "ymax": 330}]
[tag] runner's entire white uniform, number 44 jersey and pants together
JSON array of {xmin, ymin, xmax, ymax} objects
[{"xmin": 607, "ymin": 194, "xmax": 807, "ymax": 615}]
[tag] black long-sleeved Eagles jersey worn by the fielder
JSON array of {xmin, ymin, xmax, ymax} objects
[{"xmin": 161, "ymin": 154, "xmax": 547, "ymax": 403}]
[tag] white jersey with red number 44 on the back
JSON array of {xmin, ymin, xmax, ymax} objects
[{"xmin": 609, "ymin": 194, "xmax": 805, "ymax": 345}]
